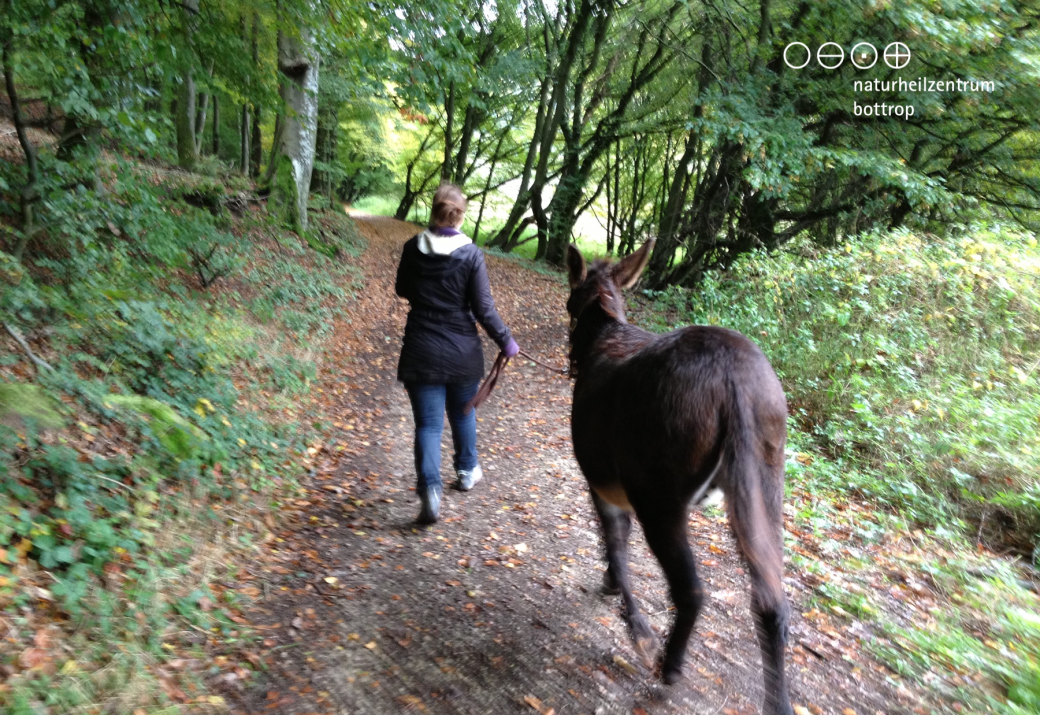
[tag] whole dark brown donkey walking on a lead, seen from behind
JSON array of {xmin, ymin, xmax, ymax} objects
[{"xmin": 567, "ymin": 242, "xmax": 791, "ymax": 715}]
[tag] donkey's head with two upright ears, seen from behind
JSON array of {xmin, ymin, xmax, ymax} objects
[{"xmin": 567, "ymin": 238, "xmax": 654, "ymax": 334}]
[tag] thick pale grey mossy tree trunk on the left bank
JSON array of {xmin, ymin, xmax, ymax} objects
[{"xmin": 268, "ymin": 28, "xmax": 319, "ymax": 232}]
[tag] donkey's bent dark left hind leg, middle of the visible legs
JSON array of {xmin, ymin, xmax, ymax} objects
[{"xmin": 640, "ymin": 506, "xmax": 704, "ymax": 685}]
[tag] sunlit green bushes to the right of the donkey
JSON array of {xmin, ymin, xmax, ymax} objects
[{"xmin": 650, "ymin": 226, "xmax": 1040, "ymax": 548}]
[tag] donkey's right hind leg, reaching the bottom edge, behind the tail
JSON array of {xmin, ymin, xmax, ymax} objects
[{"xmin": 726, "ymin": 461, "xmax": 794, "ymax": 715}]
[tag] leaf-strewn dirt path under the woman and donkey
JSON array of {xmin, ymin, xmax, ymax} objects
[{"xmin": 221, "ymin": 217, "xmax": 920, "ymax": 715}]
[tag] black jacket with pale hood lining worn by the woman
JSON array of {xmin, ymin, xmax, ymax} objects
[{"xmin": 394, "ymin": 234, "xmax": 512, "ymax": 385}]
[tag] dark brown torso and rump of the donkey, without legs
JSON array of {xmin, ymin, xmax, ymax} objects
[{"xmin": 571, "ymin": 324, "xmax": 787, "ymax": 508}]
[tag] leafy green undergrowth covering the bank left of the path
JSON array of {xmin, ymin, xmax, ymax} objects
[{"xmin": 0, "ymin": 150, "xmax": 362, "ymax": 713}]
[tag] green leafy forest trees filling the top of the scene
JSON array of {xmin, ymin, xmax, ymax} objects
[{"xmin": 0, "ymin": 0, "xmax": 1040, "ymax": 274}]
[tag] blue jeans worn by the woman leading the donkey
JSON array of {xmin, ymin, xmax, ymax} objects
[{"xmin": 405, "ymin": 382, "xmax": 478, "ymax": 492}]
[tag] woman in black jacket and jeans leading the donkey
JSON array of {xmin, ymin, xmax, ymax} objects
[{"xmin": 394, "ymin": 184, "xmax": 520, "ymax": 524}]
